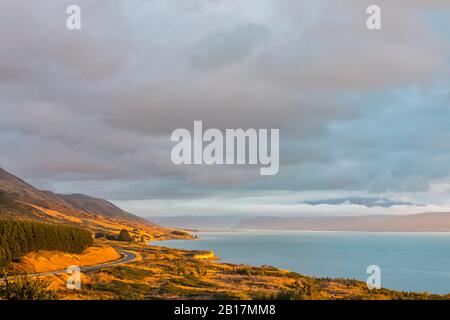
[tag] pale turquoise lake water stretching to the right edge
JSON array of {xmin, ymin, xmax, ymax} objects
[{"xmin": 154, "ymin": 231, "xmax": 450, "ymax": 293}]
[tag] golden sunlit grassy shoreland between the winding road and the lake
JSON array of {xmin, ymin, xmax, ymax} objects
[{"xmin": 35, "ymin": 244, "xmax": 449, "ymax": 300}]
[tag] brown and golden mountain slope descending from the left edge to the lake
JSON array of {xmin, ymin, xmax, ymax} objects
[{"xmin": 0, "ymin": 168, "xmax": 168, "ymax": 235}]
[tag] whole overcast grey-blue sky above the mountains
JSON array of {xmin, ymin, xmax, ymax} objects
[{"xmin": 0, "ymin": 0, "xmax": 450, "ymax": 216}]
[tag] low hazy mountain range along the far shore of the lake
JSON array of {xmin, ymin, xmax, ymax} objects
[{"xmin": 149, "ymin": 212, "xmax": 450, "ymax": 232}]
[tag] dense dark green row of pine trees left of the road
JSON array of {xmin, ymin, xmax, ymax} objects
[{"xmin": 0, "ymin": 220, "xmax": 93, "ymax": 268}]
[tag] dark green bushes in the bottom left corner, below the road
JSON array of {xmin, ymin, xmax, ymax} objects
[{"xmin": 0, "ymin": 276, "xmax": 55, "ymax": 300}]
